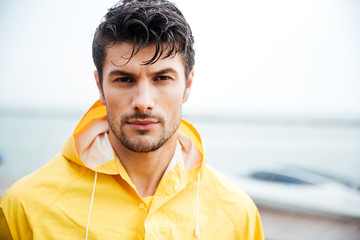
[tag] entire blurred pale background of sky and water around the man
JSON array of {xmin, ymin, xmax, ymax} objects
[{"xmin": 0, "ymin": 0, "xmax": 360, "ymax": 240}]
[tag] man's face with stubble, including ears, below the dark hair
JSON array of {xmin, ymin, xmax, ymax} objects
[{"xmin": 95, "ymin": 43, "xmax": 193, "ymax": 153}]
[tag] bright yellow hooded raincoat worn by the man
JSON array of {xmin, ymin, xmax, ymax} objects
[{"xmin": 0, "ymin": 101, "xmax": 264, "ymax": 240}]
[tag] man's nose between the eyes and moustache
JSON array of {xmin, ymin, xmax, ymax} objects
[{"xmin": 132, "ymin": 81, "xmax": 154, "ymax": 114}]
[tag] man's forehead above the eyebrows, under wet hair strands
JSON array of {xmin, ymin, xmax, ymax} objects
[{"xmin": 103, "ymin": 42, "xmax": 185, "ymax": 73}]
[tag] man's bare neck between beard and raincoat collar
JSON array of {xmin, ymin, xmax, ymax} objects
[{"xmin": 109, "ymin": 131, "xmax": 177, "ymax": 197}]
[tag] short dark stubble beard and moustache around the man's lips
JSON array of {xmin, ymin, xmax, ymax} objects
[{"xmin": 108, "ymin": 109, "xmax": 181, "ymax": 153}]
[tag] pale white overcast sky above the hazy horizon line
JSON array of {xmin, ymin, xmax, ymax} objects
[{"xmin": 0, "ymin": 0, "xmax": 360, "ymax": 117}]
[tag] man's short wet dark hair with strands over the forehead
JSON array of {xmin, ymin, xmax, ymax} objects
[{"xmin": 92, "ymin": 0, "xmax": 195, "ymax": 86}]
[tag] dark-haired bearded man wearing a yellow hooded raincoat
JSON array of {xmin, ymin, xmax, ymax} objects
[{"xmin": 0, "ymin": 0, "xmax": 263, "ymax": 239}]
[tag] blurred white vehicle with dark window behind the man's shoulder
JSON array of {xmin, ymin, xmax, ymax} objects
[{"xmin": 228, "ymin": 165, "xmax": 360, "ymax": 218}]
